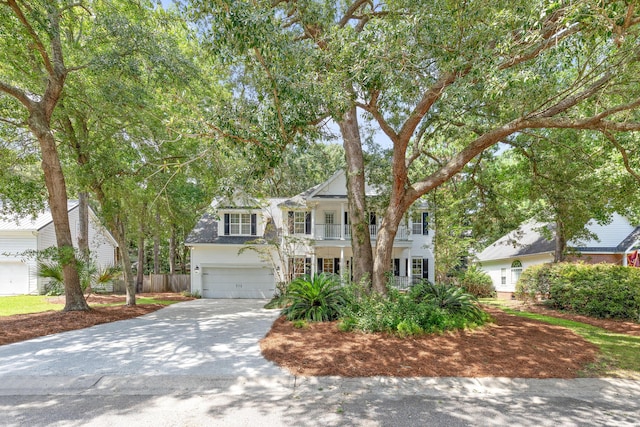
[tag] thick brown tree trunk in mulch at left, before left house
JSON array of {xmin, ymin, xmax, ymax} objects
[{"xmin": 28, "ymin": 108, "xmax": 89, "ymax": 311}]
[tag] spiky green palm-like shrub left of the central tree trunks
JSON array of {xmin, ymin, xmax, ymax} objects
[{"xmin": 282, "ymin": 273, "xmax": 346, "ymax": 322}]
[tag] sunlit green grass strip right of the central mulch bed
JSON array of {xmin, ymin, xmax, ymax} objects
[{"xmin": 482, "ymin": 300, "xmax": 640, "ymax": 379}]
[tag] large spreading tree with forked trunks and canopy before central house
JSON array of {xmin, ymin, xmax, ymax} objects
[{"xmin": 188, "ymin": 0, "xmax": 640, "ymax": 293}]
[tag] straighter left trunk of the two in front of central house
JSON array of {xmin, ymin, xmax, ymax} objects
[{"xmin": 338, "ymin": 106, "xmax": 373, "ymax": 286}]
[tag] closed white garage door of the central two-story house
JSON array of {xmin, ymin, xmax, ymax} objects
[{"xmin": 202, "ymin": 267, "xmax": 275, "ymax": 298}]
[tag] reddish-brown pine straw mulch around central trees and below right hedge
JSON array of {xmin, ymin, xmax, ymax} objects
[{"xmin": 260, "ymin": 306, "xmax": 640, "ymax": 378}]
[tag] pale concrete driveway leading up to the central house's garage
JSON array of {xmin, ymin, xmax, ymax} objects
[{"xmin": 0, "ymin": 299, "xmax": 283, "ymax": 379}]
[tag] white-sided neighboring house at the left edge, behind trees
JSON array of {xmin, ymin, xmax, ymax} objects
[{"xmin": 0, "ymin": 200, "xmax": 117, "ymax": 295}]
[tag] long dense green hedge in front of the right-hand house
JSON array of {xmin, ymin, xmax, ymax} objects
[{"xmin": 516, "ymin": 263, "xmax": 640, "ymax": 321}]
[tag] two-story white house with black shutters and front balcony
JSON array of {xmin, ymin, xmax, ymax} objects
[{"xmin": 186, "ymin": 171, "xmax": 434, "ymax": 298}]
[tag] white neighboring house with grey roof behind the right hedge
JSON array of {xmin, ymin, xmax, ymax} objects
[{"xmin": 477, "ymin": 214, "xmax": 640, "ymax": 298}]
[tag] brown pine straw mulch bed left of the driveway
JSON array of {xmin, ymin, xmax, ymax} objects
[{"xmin": 0, "ymin": 293, "xmax": 193, "ymax": 345}]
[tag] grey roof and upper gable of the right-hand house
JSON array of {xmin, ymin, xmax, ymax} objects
[{"xmin": 477, "ymin": 214, "xmax": 640, "ymax": 261}]
